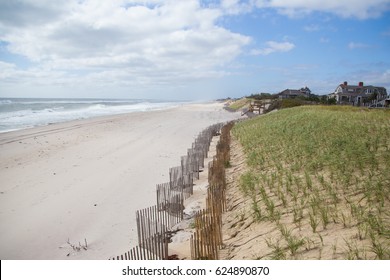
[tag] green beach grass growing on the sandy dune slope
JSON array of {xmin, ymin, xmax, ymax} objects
[{"xmin": 232, "ymin": 104, "xmax": 390, "ymax": 259}]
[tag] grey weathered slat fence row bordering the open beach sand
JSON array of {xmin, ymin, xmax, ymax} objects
[{"xmin": 111, "ymin": 124, "xmax": 223, "ymax": 260}]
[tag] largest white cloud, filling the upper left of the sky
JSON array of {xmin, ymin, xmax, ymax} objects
[{"xmin": 0, "ymin": 0, "xmax": 251, "ymax": 93}]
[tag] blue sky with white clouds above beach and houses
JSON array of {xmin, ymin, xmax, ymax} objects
[{"xmin": 0, "ymin": 0, "xmax": 390, "ymax": 100}]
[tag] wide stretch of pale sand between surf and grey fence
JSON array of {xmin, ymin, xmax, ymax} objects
[{"xmin": 0, "ymin": 103, "xmax": 240, "ymax": 259}]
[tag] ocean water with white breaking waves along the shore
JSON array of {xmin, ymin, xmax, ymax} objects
[{"xmin": 0, "ymin": 98, "xmax": 183, "ymax": 133}]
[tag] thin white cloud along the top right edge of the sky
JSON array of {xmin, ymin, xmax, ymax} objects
[{"xmin": 256, "ymin": 0, "xmax": 390, "ymax": 19}]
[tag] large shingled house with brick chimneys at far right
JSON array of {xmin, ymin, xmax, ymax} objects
[{"xmin": 329, "ymin": 82, "xmax": 387, "ymax": 106}]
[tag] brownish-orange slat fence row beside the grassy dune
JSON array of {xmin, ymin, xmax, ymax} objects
[{"xmin": 190, "ymin": 123, "xmax": 233, "ymax": 260}]
